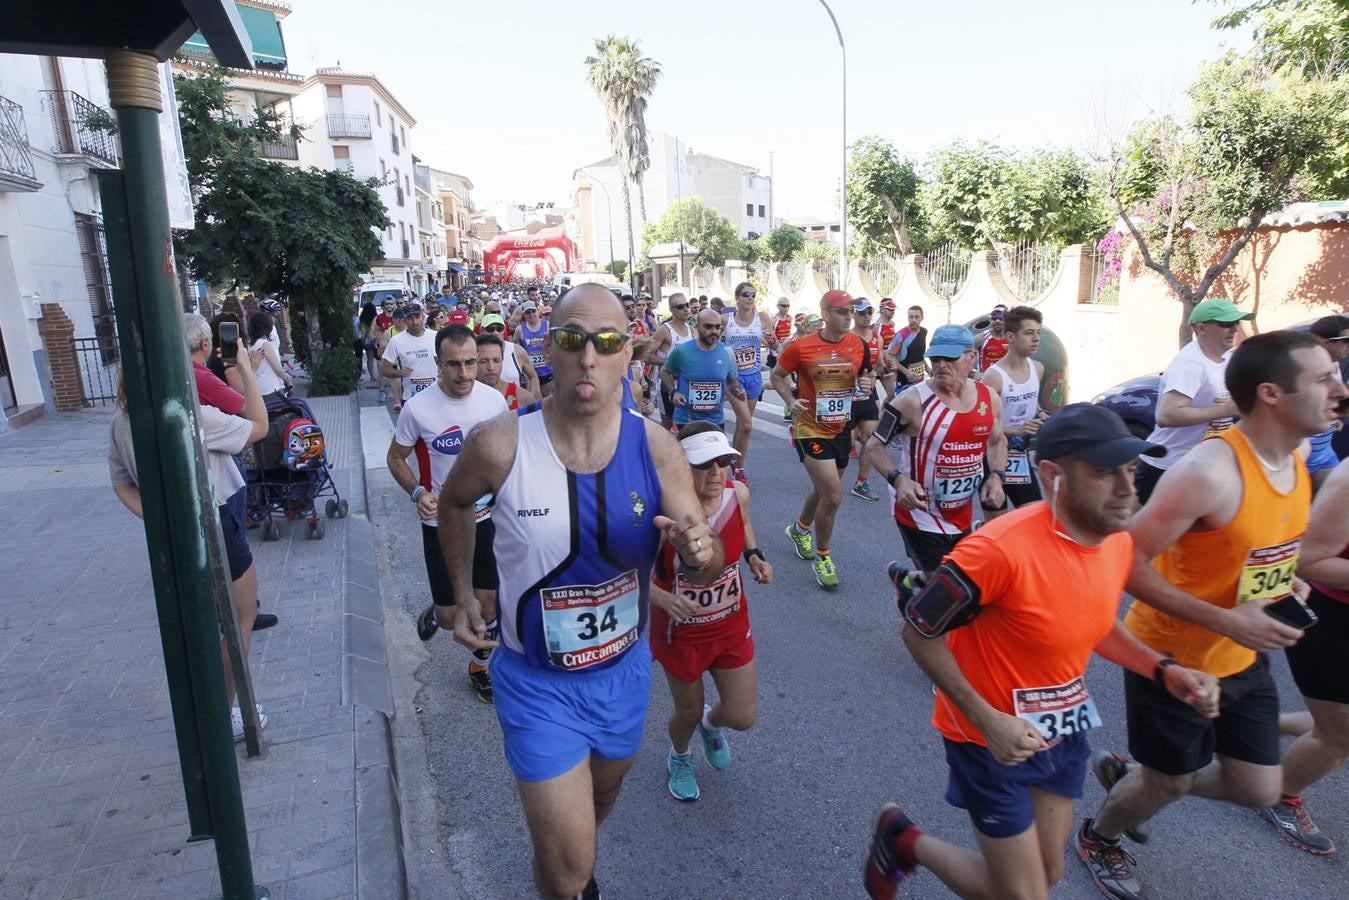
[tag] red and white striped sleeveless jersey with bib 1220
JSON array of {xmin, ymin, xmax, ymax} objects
[{"xmin": 892, "ymin": 381, "xmax": 993, "ymax": 534}]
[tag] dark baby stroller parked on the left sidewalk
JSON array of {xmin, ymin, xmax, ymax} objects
[{"xmin": 248, "ymin": 395, "xmax": 347, "ymax": 541}]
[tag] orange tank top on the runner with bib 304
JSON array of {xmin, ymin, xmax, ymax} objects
[{"xmin": 1124, "ymin": 428, "xmax": 1311, "ymax": 679}]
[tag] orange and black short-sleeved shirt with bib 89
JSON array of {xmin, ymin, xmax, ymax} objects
[{"xmin": 777, "ymin": 332, "xmax": 873, "ymax": 440}]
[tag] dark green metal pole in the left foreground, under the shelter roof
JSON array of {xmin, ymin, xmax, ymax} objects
[{"xmin": 107, "ymin": 50, "xmax": 267, "ymax": 900}]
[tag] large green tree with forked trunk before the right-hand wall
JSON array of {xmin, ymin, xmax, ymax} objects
[{"xmin": 1108, "ymin": 54, "xmax": 1346, "ymax": 344}]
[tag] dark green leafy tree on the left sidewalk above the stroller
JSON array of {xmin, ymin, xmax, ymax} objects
[{"xmin": 174, "ymin": 74, "xmax": 389, "ymax": 362}]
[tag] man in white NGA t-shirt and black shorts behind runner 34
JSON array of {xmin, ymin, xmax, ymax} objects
[{"xmin": 387, "ymin": 325, "xmax": 509, "ymax": 703}]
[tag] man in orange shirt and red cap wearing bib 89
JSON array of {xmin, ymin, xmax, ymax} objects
[{"xmin": 773, "ymin": 290, "xmax": 876, "ymax": 588}]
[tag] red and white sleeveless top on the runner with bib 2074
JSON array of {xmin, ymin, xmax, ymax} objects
[{"xmin": 650, "ymin": 482, "xmax": 750, "ymax": 644}]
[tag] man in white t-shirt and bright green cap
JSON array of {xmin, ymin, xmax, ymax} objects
[{"xmin": 1133, "ymin": 298, "xmax": 1255, "ymax": 506}]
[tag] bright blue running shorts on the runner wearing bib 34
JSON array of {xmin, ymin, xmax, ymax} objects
[{"xmin": 488, "ymin": 637, "xmax": 652, "ymax": 781}]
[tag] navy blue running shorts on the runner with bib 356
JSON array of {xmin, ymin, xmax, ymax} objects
[{"xmin": 946, "ymin": 734, "xmax": 1091, "ymax": 838}]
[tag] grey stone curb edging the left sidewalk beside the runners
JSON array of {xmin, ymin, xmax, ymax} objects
[{"xmin": 341, "ymin": 397, "xmax": 409, "ymax": 900}]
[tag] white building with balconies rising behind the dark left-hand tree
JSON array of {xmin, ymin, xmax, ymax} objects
[{"xmin": 290, "ymin": 67, "xmax": 428, "ymax": 290}]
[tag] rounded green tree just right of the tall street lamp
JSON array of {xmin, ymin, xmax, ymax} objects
[{"xmin": 847, "ymin": 135, "xmax": 923, "ymax": 258}]
